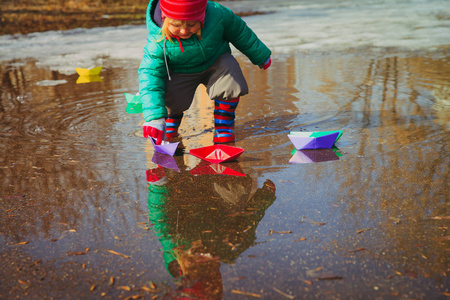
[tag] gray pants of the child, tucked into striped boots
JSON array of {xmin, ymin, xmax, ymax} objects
[{"xmin": 165, "ymin": 52, "xmax": 248, "ymax": 115}]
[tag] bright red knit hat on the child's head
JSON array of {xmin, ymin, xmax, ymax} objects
[{"xmin": 160, "ymin": 0, "xmax": 207, "ymax": 27}]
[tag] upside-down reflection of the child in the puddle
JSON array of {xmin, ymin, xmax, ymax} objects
[{"xmin": 147, "ymin": 157, "xmax": 275, "ymax": 299}]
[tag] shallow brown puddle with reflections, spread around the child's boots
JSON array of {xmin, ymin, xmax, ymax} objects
[{"xmin": 0, "ymin": 49, "xmax": 450, "ymax": 299}]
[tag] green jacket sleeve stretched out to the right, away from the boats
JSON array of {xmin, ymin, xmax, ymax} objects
[{"xmin": 222, "ymin": 7, "xmax": 271, "ymax": 65}]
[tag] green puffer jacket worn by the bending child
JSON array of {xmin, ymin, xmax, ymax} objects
[{"xmin": 138, "ymin": 0, "xmax": 271, "ymax": 122}]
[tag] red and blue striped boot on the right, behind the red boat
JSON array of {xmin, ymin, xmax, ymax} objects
[{"xmin": 213, "ymin": 97, "xmax": 239, "ymax": 144}]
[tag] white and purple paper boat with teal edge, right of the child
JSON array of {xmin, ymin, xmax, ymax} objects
[{"xmin": 288, "ymin": 130, "xmax": 342, "ymax": 150}]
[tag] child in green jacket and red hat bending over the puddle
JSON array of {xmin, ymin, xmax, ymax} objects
[{"xmin": 139, "ymin": 0, "xmax": 271, "ymax": 145}]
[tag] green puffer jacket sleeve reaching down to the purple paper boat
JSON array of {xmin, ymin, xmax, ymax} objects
[{"xmin": 138, "ymin": 41, "xmax": 167, "ymax": 122}]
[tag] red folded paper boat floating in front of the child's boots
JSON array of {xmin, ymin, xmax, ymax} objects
[{"xmin": 189, "ymin": 145, "xmax": 244, "ymax": 164}]
